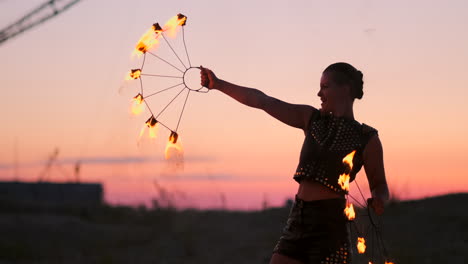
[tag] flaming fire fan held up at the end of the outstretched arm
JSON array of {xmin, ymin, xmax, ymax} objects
[{"xmin": 122, "ymin": 14, "xmax": 209, "ymax": 159}]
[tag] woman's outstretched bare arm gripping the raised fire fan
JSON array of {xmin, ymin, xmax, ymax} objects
[{"xmin": 200, "ymin": 67, "xmax": 315, "ymax": 130}]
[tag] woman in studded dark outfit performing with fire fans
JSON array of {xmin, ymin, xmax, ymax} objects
[{"xmin": 200, "ymin": 62, "xmax": 389, "ymax": 264}]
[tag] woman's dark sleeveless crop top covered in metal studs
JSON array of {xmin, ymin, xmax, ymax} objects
[{"xmin": 294, "ymin": 110, "xmax": 377, "ymax": 193}]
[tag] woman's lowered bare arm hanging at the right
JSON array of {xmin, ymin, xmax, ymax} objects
[{"xmin": 364, "ymin": 135, "xmax": 390, "ymax": 215}]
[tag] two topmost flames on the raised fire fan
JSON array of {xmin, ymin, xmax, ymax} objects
[{"xmin": 133, "ymin": 14, "xmax": 187, "ymax": 55}]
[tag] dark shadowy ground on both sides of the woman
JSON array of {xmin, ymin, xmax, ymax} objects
[{"xmin": 0, "ymin": 193, "xmax": 468, "ymax": 264}]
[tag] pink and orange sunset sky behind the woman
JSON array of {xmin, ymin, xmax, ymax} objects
[{"xmin": 0, "ymin": 0, "xmax": 468, "ymax": 209}]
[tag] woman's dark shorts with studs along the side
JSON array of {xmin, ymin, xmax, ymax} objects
[{"xmin": 273, "ymin": 197, "xmax": 351, "ymax": 264}]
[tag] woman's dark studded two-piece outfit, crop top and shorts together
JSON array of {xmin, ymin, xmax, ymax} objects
[{"xmin": 273, "ymin": 110, "xmax": 377, "ymax": 264}]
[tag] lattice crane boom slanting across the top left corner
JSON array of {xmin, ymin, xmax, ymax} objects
[{"xmin": 0, "ymin": 0, "xmax": 80, "ymax": 44}]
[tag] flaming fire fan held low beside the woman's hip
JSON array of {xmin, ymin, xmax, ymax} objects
[{"xmin": 338, "ymin": 151, "xmax": 394, "ymax": 264}]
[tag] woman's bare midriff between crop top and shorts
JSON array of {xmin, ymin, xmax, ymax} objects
[{"xmin": 297, "ymin": 180, "xmax": 344, "ymax": 201}]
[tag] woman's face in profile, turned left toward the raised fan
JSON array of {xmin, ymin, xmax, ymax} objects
[{"xmin": 317, "ymin": 72, "xmax": 351, "ymax": 113}]
